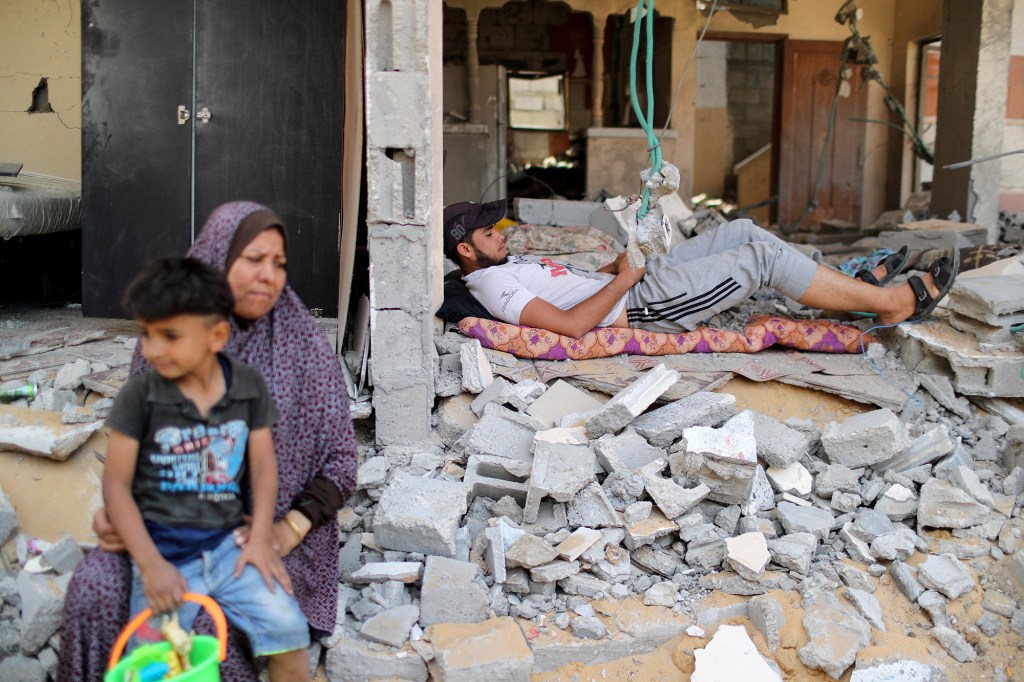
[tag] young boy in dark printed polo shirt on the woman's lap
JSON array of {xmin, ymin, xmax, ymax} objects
[{"xmin": 103, "ymin": 258, "xmax": 309, "ymax": 682}]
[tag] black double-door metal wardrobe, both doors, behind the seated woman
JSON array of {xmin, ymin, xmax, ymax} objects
[{"xmin": 82, "ymin": 0, "xmax": 345, "ymax": 316}]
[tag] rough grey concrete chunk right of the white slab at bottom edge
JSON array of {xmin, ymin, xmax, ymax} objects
[{"xmin": 797, "ymin": 591, "xmax": 871, "ymax": 679}]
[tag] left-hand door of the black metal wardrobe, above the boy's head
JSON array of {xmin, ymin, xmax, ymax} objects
[{"xmin": 82, "ymin": 0, "xmax": 193, "ymax": 317}]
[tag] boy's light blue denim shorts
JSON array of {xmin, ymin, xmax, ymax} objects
[{"xmin": 131, "ymin": 534, "xmax": 309, "ymax": 656}]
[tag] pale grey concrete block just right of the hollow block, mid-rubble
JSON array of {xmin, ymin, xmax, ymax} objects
[{"xmin": 523, "ymin": 440, "xmax": 596, "ymax": 523}]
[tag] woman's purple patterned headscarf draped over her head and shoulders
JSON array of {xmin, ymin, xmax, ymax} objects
[{"xmin": 131, "ymin": 202, "xmax": 357, "ymax": 632}]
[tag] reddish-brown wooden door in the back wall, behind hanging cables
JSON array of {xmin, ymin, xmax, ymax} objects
[{"xmin": 777, "ymin": 40, "xmax": 867, "ymax": 231}]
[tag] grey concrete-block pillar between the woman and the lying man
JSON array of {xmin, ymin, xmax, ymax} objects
[{"xmin": 365, "ymin": 0, "xmax": 442, "ymax": 446}]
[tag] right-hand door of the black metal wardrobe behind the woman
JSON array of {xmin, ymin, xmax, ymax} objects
[{"xmin": 196, "ymin": 0, "xmax": 345, "ymax": 315}]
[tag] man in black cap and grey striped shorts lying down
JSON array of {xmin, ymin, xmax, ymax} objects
[{"xmin": 443, "ymin": 200, "xmax": 958, "ymax": 338}]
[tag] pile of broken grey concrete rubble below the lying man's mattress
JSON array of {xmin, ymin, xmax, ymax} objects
[{"xmin": 305, "ymin": 323, "xmax": 1024, "ymax": 680}]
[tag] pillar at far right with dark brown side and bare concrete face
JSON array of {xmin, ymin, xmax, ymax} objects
[{"xmin": 932, "ymin": 0, "xmax": 1014, "ymax": 243}]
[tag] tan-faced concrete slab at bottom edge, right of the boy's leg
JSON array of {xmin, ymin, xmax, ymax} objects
[{"xmin": 427, "ymin": 617, "xmax": 534, "ymax": 682}]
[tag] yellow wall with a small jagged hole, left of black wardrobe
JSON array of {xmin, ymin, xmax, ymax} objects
[{"xmin": 0, "ymin": 0, "xmax": 82, "ymax": 180}]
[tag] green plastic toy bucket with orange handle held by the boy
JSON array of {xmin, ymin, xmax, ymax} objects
[{"xmin": 103, "ymin": 592, "xmax": 227, "ymax": 682}]
